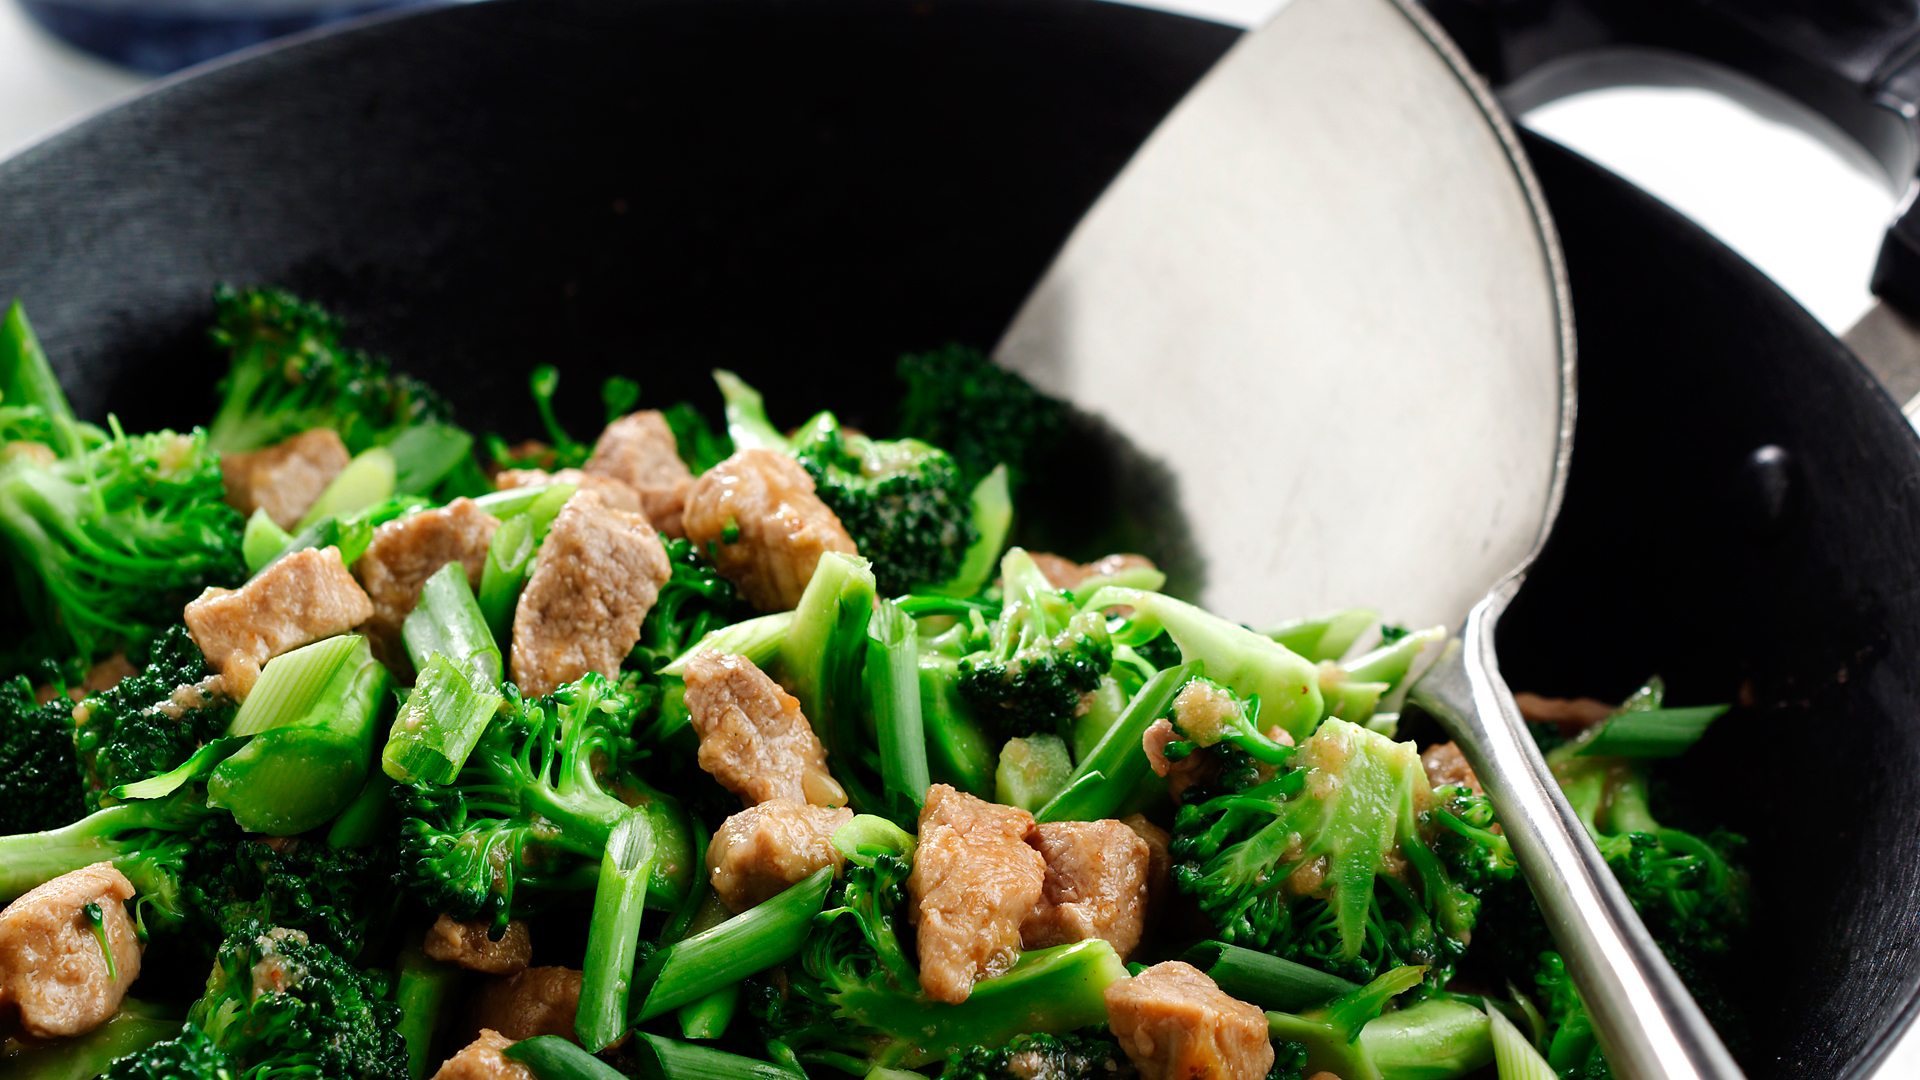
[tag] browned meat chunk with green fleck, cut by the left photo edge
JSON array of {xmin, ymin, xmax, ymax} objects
[{"xmin": 0, "ymin": 863, "xmax": 140, "ymax": 1040}]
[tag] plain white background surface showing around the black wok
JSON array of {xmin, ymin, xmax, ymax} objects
[{"xmin": 0, "ymin": 0, "xmax": 1920, "ymax": 1076}]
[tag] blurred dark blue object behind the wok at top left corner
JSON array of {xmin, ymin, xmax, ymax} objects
[{"xmin": 19, "ymin": 0, "xmax": 449, "ymax": 75}]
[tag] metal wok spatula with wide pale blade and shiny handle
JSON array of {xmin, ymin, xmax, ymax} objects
[{"xmin": 998, "ymin": 0, "xmax": 1740, "ymax": 1080}]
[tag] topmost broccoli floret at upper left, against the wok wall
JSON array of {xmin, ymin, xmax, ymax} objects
[{"xmin": 207, "ymin": 284, "xmax": 453, "ymax": 451}]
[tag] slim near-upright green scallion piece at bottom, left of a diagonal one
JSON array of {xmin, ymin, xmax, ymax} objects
[{"xmin": 574, "ymin": 809, "xmax": 653, "ymax": 1051}]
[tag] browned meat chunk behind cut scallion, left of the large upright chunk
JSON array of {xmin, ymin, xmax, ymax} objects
[{"xmin": 353, "ymin": 498, "xmax": 499, "ymax": 667}]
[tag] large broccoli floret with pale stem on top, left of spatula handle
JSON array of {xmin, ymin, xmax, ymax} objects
[{"xmin": 1171, "ymin": 719, "xmax": 1509, "ymax": 986}]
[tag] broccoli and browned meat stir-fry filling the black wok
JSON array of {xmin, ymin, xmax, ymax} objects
[{"xmin": 0, "ymin": 288, "xmax": 1747, "ymax": 1080}]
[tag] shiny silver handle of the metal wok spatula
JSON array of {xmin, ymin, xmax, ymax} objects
[{"xmin": 1413, "ymin": 577, "xmax": 1741, "ymax": 1080}]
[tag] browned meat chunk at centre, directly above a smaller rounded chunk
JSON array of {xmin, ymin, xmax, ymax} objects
[{"xmin": 684, "ymin": 650, "xmax": 847, "ymax": 807}]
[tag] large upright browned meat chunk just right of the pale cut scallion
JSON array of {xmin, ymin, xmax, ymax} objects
[{"xmin": 513, "ymin": 492, "xmax": 672, "ymax": 698}]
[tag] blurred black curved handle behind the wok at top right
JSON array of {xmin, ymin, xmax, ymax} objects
[{"xmin": 1423, "ymin": 0, "xmax": 1920, "ymax": 319}]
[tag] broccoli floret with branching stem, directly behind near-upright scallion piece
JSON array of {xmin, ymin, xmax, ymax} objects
[{"xmin": 396, "ymin": 673, "xmax": 693, "ymax": 926}]
